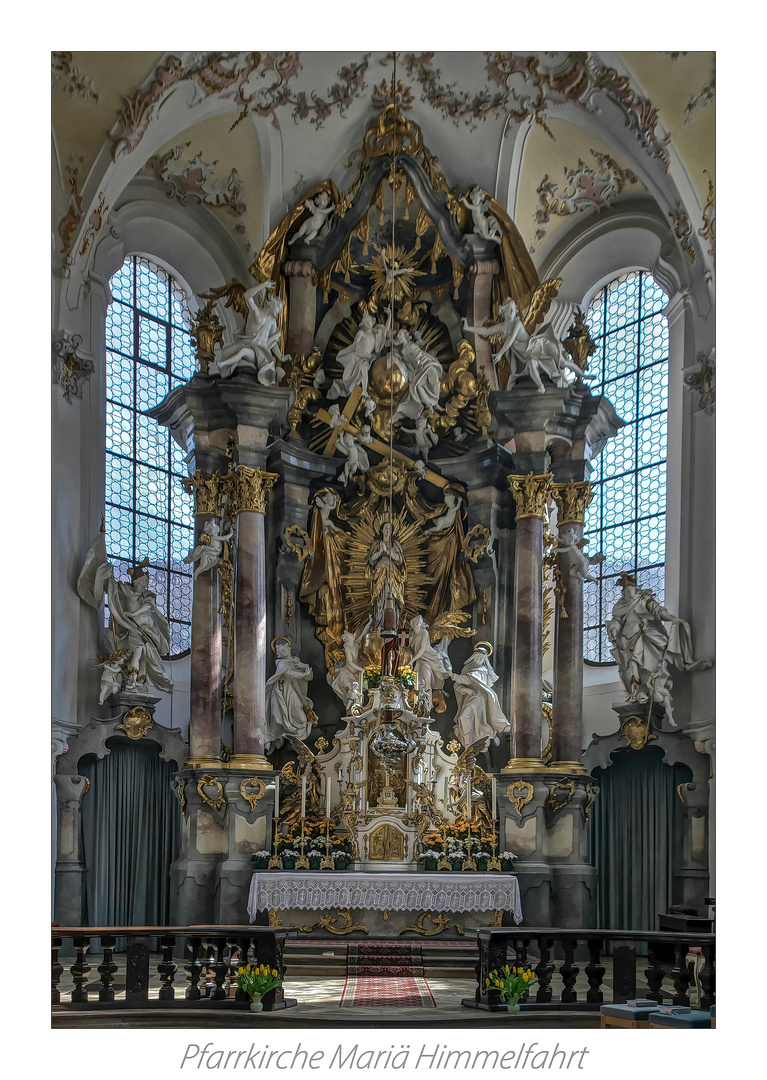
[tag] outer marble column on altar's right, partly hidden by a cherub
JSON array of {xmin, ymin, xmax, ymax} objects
[{"xmin": 549, "ymin": 481, "xmax": 594, "ymax": 772}]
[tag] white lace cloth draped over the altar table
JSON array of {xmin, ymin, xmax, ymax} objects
[{"xmin": 247, "ymin": 870, "xmax": 522, "ymax": 926}]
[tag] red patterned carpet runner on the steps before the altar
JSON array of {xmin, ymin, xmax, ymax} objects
[{"xmin": 339, "ymin": 942, "xmax": 436, "ymax": 1009}]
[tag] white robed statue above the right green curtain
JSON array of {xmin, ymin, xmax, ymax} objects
[{"xmin": 607, "ymin": 573, "xmax": 713, "ymax": 727}]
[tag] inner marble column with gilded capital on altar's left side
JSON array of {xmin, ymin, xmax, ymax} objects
[{"xmin": 229, "ymin": 465, "xmax": 279, "ymax": 769}]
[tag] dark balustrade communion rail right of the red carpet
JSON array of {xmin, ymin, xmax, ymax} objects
[{"xmin": 461, "ymin": 927, "xmax": 716, "ymax": 1012}]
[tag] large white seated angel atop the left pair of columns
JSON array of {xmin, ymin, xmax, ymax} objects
[{"xmin": 211, "ymin": 281, "xmax": 291, "ymax": 387}]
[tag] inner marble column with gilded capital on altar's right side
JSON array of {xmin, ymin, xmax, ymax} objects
[{"xmin": 503, "ymin": 472, "xmax": 553, "ymax": 772}]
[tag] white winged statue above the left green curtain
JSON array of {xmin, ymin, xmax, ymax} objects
[{"xmin": 77, "ymin": 532, "xmax": 173, "ymax": 693}]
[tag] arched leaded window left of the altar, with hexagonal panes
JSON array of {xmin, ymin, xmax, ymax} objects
[{"xmin": 106, "ymin": 256, "xmax": 196, "ymax": 657}]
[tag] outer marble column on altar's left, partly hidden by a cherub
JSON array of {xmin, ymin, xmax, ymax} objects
[{"xmin": 183, "ymin": 469, "xmax": 221, "ymax": 768}]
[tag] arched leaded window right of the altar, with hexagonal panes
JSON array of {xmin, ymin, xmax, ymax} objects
[{"xmin": 583, "ymin": 272, "xmax": 669, "ymax": 663}]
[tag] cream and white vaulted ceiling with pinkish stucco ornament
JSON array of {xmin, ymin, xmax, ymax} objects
[{"xmin": 52, "ymin": 52, "xmax": 715, "ymax": 308}]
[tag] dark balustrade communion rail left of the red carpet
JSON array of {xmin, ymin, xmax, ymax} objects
[{"xmin": 51, "ymin": 927, "xmax": 296, "ymax": 1012}]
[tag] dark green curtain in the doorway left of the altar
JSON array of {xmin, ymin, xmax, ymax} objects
[{"xmin": 80, "ymin": 739, "xmax": 180, "ymax": 927}]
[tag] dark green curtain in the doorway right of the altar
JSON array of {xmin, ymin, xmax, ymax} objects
[{"xmin": 592, "ymin": 745, "xmax": 692, "ymax": 930}]
